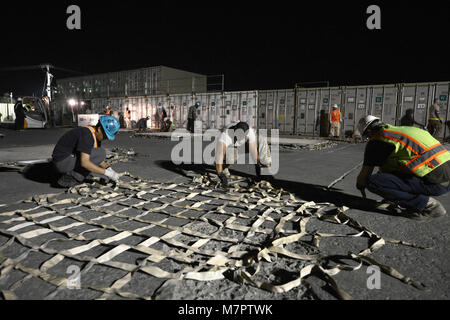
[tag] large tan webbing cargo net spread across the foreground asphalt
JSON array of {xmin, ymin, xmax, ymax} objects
[{"xmin": 0, "ymin": 173, "xmax": 425, "ymax": 299}]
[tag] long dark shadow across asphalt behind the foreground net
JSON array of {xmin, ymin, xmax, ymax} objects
[{"xmin": 156, "ymin": 161, "xmax": 400, "ymax": 216}]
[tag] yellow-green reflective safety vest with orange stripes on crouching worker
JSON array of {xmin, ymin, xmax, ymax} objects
[{"xmin": 375, "ymin": 125, "xmax": 450, "ymax": 178}]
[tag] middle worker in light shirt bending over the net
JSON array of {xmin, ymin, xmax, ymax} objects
[{"xmin": 216, "ymin": 122, "xmax": 272, "ymax": 185}]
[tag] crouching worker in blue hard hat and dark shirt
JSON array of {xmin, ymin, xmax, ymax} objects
[{"xmin": 52, "ymin": 116, "xmax": 120, "ymax": 188}]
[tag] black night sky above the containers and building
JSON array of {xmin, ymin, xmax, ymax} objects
[{"xmin": 0, "ymin": 0, "xmax": 450, "ymax": 95}]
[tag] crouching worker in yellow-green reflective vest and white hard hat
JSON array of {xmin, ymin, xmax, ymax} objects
[{"xmin": 356, "ymin": 116, "xmax": 450, "ymax": 220}]
